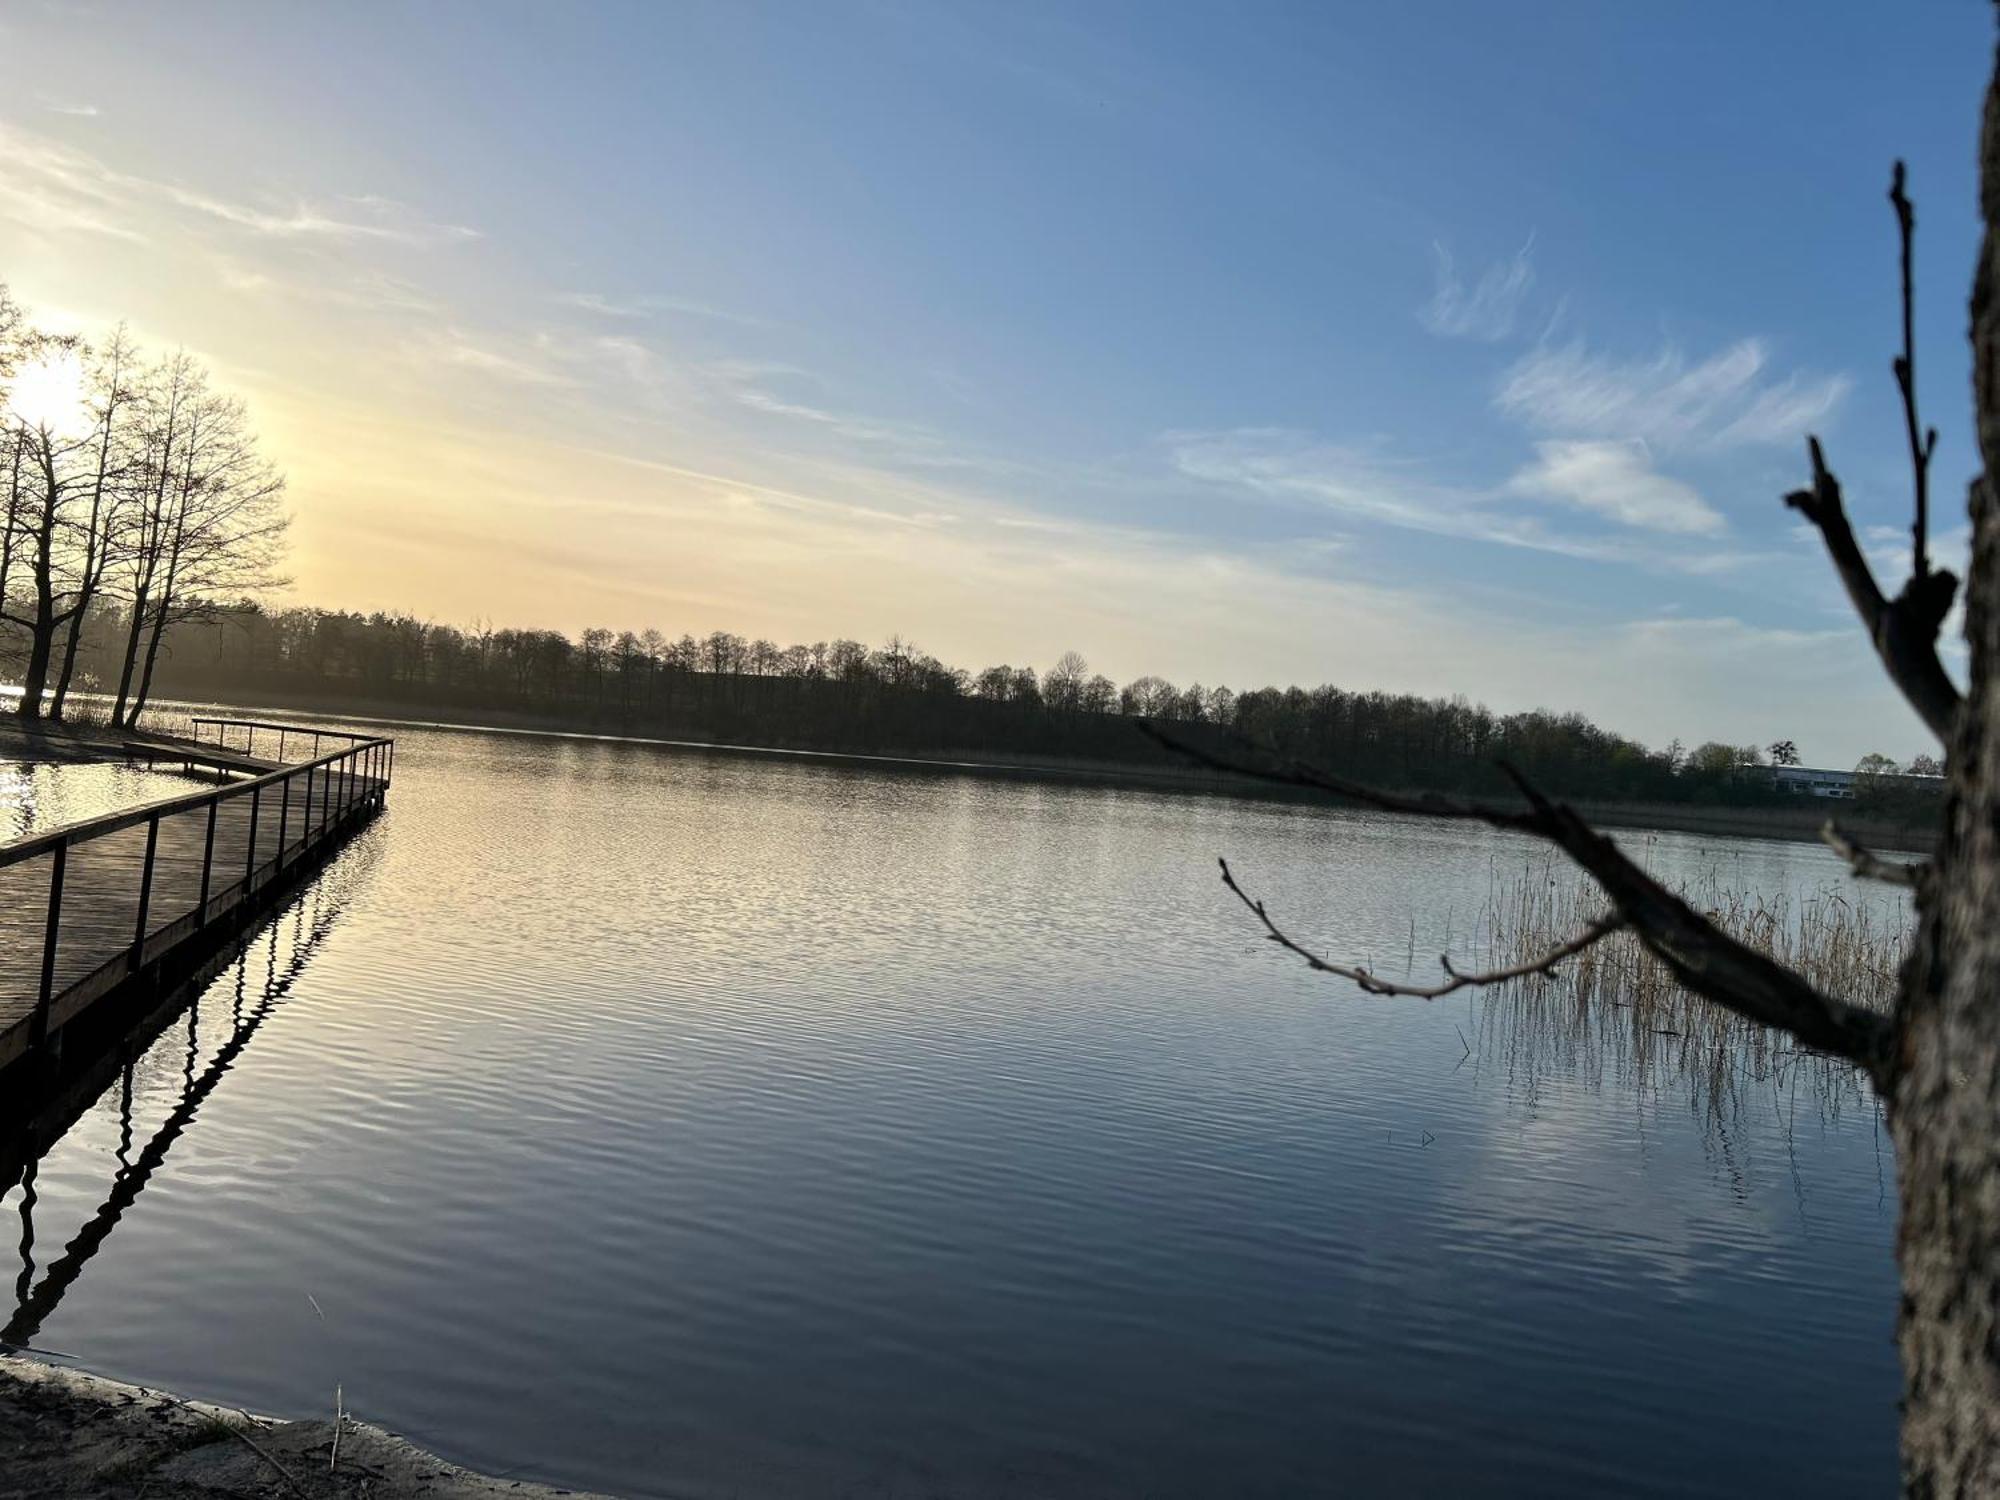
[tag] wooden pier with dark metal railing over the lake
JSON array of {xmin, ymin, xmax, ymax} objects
[{"xmin": 0, "ymin": 718, "xmax": 396, "ymax": 1068}]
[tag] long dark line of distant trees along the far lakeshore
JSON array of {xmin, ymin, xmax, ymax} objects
[{"xmin": 62, "ymin": 602, "xmax": 1928, "ymax": 802}]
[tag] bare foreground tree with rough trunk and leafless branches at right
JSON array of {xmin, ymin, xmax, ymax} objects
[{"xmin": 1148, "ymin": 58, "xmax": 2000, "ymax": 1496}]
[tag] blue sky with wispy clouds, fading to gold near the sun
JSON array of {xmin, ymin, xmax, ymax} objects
[{"xmin": 0, "ymin": 0, "xmax": 1994, "ymax": 766}]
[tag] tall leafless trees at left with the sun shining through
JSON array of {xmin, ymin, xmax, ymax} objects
[{"xmin": 0, "ymin": 284, "xmax": 286, "ymax": 724}]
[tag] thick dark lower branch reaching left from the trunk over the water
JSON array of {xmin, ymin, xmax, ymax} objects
[{"xmin": 1140, "ymin": 720, "xmax": 1894, "ymax": 1084}]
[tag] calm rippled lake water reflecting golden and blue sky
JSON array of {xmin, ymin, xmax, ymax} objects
[{"xmin": 0, "ymin": 732, "xmax": 1898, "ymax": 1500}]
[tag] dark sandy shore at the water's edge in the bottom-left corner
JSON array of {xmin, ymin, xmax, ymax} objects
[{"xmin": 0, "ymin": 1358, "xmax": 604, "ymax": 1500}]
